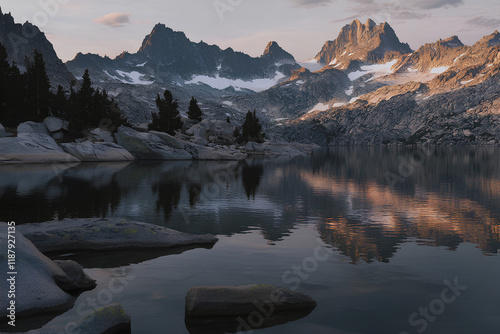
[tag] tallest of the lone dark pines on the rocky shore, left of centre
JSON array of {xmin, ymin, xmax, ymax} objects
[{"xmin": 148, "ymin": 89, "xmax": 182, "ymax": 135}]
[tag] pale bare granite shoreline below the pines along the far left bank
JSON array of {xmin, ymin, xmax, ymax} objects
[{"xmin": 0, "ymin": 117, "xmax": 319, "ymax": 164}]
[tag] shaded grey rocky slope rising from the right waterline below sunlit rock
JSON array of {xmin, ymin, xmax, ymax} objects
[{"xmin": 288, "ymin": 73, "xmax": 500, "ymax": 145}]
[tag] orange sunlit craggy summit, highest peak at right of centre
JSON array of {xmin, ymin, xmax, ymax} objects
[{"xmin": 315, "ymin": 20, "xmax": 411, "ymax": 69}]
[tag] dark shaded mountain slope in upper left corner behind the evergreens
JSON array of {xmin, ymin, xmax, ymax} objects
[{"xmin": 0, "ymin": 8, "xmax": 74, "ymax": 88}]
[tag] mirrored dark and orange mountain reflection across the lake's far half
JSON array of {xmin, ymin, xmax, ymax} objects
[{"xmin": 0, "ymin": 148, "xmax": 500, "ymax": 263}]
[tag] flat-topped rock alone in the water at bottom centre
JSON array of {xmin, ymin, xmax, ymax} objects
[{"xmin": 186, "ymin": 284, "xmax": 316, "ymax": 317}]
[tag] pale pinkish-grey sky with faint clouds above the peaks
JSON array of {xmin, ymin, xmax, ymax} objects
[{"xmin": 0, "ymin": 0, "xmax": 500, "ymax": 61}]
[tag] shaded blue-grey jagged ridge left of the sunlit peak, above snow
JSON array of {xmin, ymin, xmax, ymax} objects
[{"xmin": 66, "ymin": 24, "xmax": 298, "ymax": 83}]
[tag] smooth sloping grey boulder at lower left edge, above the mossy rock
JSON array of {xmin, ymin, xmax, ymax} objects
[{"xmin": 0, "ymin": 223, "xmax": 96, "ymax": 322}]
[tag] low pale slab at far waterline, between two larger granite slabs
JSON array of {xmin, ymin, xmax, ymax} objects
[{"xmin": 61, "ymin": 141, "xmax": 135, "ymax": 162}]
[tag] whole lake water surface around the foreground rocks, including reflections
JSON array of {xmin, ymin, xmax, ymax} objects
[{"xmin": 0, "ymin": 148, "xmax": 500, "ymax": 334}]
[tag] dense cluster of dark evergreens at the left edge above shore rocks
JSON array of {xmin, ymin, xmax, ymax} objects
[{"xmin": 0, "ymin": 44, "xmax": 126, "ymax": 134}]
